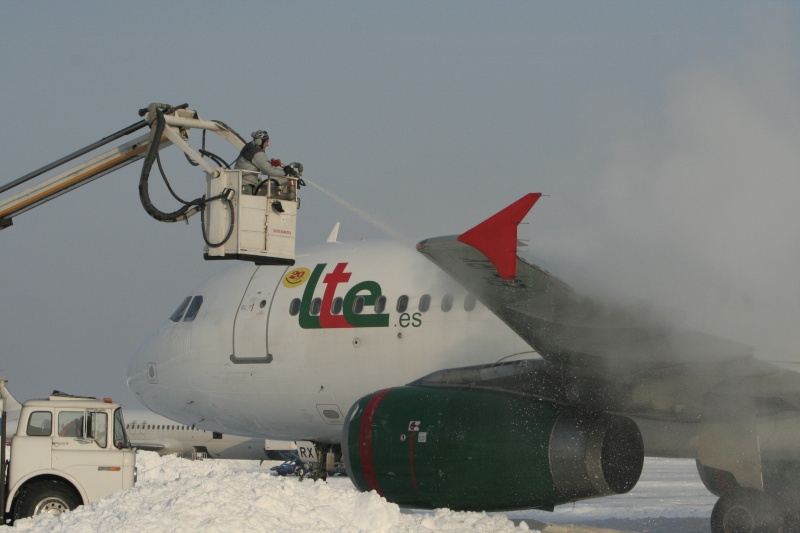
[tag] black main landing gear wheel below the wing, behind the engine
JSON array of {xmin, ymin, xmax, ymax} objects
[{"xmin": 711, "ymin": 489, "xmax": 788, "ymax": 533}]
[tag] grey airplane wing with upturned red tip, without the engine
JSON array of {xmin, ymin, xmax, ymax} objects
[{"xmin": 417, "ymin": 194, "xmax": 800, "ymax": 419}]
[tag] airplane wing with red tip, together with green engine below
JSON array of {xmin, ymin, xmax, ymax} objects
[{"xmin": 342, "ymin": 194, "xmax": 800, "ymax": 531}]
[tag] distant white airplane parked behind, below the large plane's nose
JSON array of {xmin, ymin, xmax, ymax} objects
[{"xmin": 125, "ymin": 410, "xmax": 297, "ymax": 461}]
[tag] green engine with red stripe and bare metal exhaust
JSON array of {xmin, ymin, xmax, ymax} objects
[{"xmin": 342, "ymin": 386, "xmax": 644, "ymax": 511}]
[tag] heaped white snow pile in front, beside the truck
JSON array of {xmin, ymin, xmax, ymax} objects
[{"xmin": 7, "ymin": 452, "xmax": 528, "ymax": 533}]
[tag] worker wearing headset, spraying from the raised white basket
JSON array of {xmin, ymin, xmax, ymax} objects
[{"xmin": 238, "ymin": 130, "xmax": 302, "ymax": 200}]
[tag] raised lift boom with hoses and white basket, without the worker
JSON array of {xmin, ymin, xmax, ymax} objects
[{"xmin": 0, "ymin": 103, "xmax": 302, "ymax": 264}]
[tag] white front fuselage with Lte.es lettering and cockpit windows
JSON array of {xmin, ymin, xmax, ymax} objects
[{"xmin": 128, "ymin": 242, "xmax": 536, "ymax": 442}]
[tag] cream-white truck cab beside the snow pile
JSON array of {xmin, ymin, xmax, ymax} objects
[{"xmin": 0, "ymin": 378, "xmax": 136, "ymax": 524}]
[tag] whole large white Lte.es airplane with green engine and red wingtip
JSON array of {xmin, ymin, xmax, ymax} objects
[{"xmin": 128, "ymin": 193, "xmax": 800, "ymax": 532}]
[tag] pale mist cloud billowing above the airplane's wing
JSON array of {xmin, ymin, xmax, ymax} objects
[{"xmin": 532, "ymin": 6, "xmax": 800, "ymax": 359}]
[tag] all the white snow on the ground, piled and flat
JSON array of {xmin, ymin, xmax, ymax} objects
[{"xmin": 0, "ymin": 452, "xmax": 715, "ymax": 533}]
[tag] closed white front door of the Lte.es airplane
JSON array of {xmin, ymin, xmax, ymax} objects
[{"xmin": 231, "ymin": 266, "xmax": 285, "ymax": 363}]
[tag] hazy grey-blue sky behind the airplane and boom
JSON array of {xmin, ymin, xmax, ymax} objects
[{"xmin": 0, "ymin": 1, "xmax": 800, "ymax": 408}]
